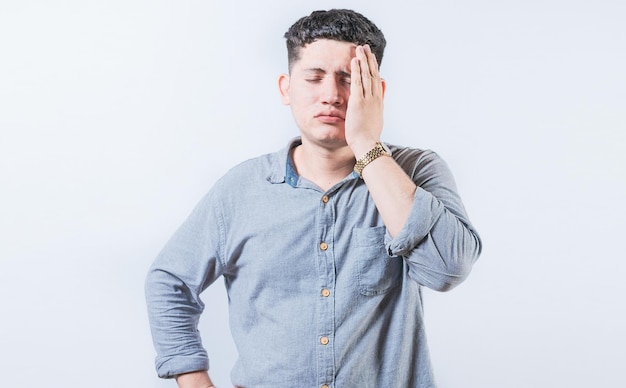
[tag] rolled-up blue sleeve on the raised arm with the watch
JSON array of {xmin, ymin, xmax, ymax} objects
[{"xmin": 387, "ymin": 150, "xmax": 482, "ymax": 291}]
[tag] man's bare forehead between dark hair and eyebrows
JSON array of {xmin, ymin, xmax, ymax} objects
[{"xmin": 294, "ymin": 39, "xmax": 356, "ymax": 70}]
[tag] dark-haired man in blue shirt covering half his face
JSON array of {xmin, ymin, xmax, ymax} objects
[{"xmin": 146, "ymin": 10, "xmax": 481, "ymax": 388}]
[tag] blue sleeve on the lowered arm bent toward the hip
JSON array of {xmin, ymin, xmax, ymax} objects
[{"xmin": 145, "ymin": 195, "xmax": 224, "ymax": 378}]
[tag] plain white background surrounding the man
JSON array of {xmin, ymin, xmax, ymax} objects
[{"xmin": 0, "ymin": 0, "xmax": 626, "ymax": 388}]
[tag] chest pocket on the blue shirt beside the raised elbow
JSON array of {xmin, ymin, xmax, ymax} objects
[{"xmin": 354, "ymin": 226, "xmax": 403, "ymax": 296}]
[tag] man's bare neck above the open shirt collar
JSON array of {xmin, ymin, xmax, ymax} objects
[{"xmin": 292, "ymin": 140, "xmax": 355, "ymax": 191}]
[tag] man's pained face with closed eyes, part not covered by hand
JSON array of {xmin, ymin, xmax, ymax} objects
[{"xmin": 279, "ymin": 39, "xmax": 356, "ymax": 148}]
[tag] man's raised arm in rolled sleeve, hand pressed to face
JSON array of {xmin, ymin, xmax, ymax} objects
[{"xmin": 346, "ymin": 46, "xmax": 481, "ymax": 291}]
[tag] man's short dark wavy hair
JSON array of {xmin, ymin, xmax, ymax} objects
[{"xmin": 285, "ymin": 9, "xmax": 387, "ymax": 71}]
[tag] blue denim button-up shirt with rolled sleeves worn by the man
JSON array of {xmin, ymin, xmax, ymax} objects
[{"xmin": 146, "ymin": 139, "xmax": 480, "ymax": 388}]
